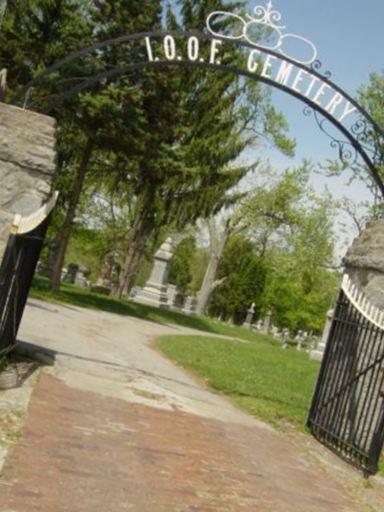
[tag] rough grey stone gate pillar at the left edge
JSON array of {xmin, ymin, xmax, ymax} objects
[{"xmin": 0, "ymin": 103, "xmax": 56, "ymax": 261}]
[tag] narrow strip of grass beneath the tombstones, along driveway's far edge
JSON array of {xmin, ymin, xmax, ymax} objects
[{"xmin": 30, "ymin": 276, "xmax": 270, "ymax": 341}]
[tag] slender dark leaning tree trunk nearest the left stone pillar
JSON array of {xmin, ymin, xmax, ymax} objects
[{"xmin": 50, "ymin": 139, "xmax": 94, "ymax": 294}]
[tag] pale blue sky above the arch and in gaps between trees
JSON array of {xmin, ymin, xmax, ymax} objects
[{"xmin": 219, "ymin": 0, "xmax": 384, "ymax": 256}]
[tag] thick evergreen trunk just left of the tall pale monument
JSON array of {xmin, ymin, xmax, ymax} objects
[{"xmin": 114, "ymin": 191, "xmax": 154, "ymax": 299}]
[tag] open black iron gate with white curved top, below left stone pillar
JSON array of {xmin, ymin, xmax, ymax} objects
[{"xmin": 0, "ymin": 194, "xmax": 57, "ymax": 355}]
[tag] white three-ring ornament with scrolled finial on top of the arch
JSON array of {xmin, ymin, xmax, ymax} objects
[{"xmin": 207, "ymin": 1, "xmax": 318, "ymax": 65}]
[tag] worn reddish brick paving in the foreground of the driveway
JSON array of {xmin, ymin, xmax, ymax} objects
[{"xmin": 0, "ymin": 373, "xmax": 363, "ymax": 512}]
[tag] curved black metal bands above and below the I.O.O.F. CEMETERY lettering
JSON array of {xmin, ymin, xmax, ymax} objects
[{"xmin": 13, "ymin": 30, "xmax": 384, "ymax": 197}]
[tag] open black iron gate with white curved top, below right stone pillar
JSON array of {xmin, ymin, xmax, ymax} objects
[{"xmin": 308, "ymin": 276, "xmax": 384, "ymax": 474}]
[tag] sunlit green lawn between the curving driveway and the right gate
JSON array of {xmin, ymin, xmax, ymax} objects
[{"xmin": 158, "ymin": 336, "xmax": 319, "ymax": 429}]
